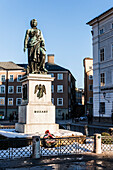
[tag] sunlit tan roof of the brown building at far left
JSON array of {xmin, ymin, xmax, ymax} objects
[{"xmin": 0, "ymin": 61, "xmax": 24, "ymax": 70}]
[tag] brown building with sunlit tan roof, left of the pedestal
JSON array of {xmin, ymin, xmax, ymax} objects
[{"xmin": 0, "ymin": 62, "xmax": 25, "ymax": 119}]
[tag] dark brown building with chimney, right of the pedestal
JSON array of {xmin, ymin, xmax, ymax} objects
[{"xmin": 46, "ymin": 55, "xmax": 76, "ymax": 119}]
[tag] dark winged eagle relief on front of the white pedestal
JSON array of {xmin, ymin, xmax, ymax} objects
[{"xmin": 34, "ymin": 84, "xmax": 46, "ymax": 99}]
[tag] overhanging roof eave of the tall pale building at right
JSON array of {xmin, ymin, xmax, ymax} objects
[{"xmin": 86, "ymin": 7, "xmax": 113, "ymax": 26}]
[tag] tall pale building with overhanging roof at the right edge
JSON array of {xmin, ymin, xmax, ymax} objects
[{"xmin": 87, "ymin": 8, "xmax": 113, "ymax": 121}]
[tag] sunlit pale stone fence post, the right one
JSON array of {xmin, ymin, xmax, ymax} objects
[{"xmin": 94, "ymin": 133, "xmax": 101, "ymax": 154}]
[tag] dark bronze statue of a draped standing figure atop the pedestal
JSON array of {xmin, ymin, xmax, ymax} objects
[{"xmin": 24, "ymin": 19, "xmax": 47, "ymax": 74}]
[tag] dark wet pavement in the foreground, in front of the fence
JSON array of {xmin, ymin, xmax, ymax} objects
[{"xmin": 0, "ymin": 152, "xmax": 113, "ymax": 170}]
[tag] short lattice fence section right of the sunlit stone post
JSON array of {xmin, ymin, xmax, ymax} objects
[{"xmin": 101, "ymin": 136, "xmax": 113, "ymax": 152}]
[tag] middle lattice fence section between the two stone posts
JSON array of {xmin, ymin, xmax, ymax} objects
[{"xmin": 40, "ymin": 136, "xmax": 94, "ymax": 156}]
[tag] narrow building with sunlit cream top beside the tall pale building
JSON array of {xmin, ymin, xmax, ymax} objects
[{"xmin": 83, "ymin": 58, "xmax": 93, "ymax": 115}]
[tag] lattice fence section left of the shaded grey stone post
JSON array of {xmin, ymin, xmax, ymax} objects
[{"xmin": 0, "ymin": 138, "xmax": 32, "ymax": 159}]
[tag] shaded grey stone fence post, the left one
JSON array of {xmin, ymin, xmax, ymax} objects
[{"xmin": 32, "ymin": 136, "xmax": 40, "ymax": 158}]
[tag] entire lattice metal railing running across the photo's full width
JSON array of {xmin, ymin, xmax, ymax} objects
[{"xmin": 0, "ymin": 135, "xmax": 113, "ymax": 159}]
